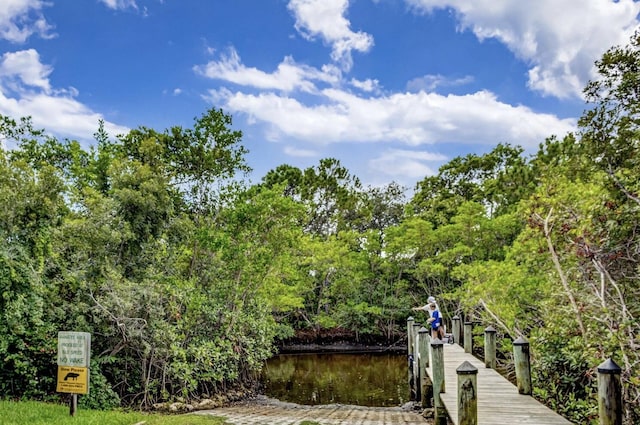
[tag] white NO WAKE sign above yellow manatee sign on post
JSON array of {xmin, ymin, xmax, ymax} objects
[{"xmin": 56, "ymin": 331, "xmax": 91, "ymax": 416}]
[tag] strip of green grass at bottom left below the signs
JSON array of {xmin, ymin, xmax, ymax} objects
[{"xmin": 0, "ymin": 400, "xmax": 230, "ymax": 425}]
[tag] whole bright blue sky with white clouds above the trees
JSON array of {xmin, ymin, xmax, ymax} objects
[{"xmin": 0, "ymin": 0, "xmax": 640, "ymax": 188}]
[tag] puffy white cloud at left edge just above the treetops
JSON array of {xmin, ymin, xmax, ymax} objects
[{"xmin": 0, "ymin": 49, "xmax": 128, "ymax": 140}]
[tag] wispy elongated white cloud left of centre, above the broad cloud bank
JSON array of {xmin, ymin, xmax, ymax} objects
[{"xmin": 193, "ymin": 49, "xmax": 340, "ymax": 92}]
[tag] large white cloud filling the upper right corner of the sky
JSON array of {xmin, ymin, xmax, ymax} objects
[{"xmin": 405, "ymin": 0, "xmax": 640, "ymax": 98}]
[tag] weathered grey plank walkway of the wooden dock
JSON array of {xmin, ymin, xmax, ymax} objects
[{"xmin": 427, "ymin": 344, "xmax": 571, "ymax": 425}]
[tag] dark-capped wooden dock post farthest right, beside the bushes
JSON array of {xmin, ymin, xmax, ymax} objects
[{"xmin": 598, "ymin": 359, "xmax": 622, "ymax": 425}]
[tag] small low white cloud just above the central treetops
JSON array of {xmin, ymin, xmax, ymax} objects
[{"xmin": 369, "ymin": 149, "xmax": 447, "ymax": 179}]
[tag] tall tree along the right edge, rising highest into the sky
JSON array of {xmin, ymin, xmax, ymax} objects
[{"xmin": 576, "ymin": 32, "xmax": 640, "ymax": 423}]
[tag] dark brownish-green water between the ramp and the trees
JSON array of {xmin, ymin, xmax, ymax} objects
[{"xmin": 262, "ymin": 353, "xmax": 409, "ymax": 407}]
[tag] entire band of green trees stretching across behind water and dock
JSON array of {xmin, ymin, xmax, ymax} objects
[{"xmin": 0, "ymin": 35, "xmax": 640, "ymax": 423}]
